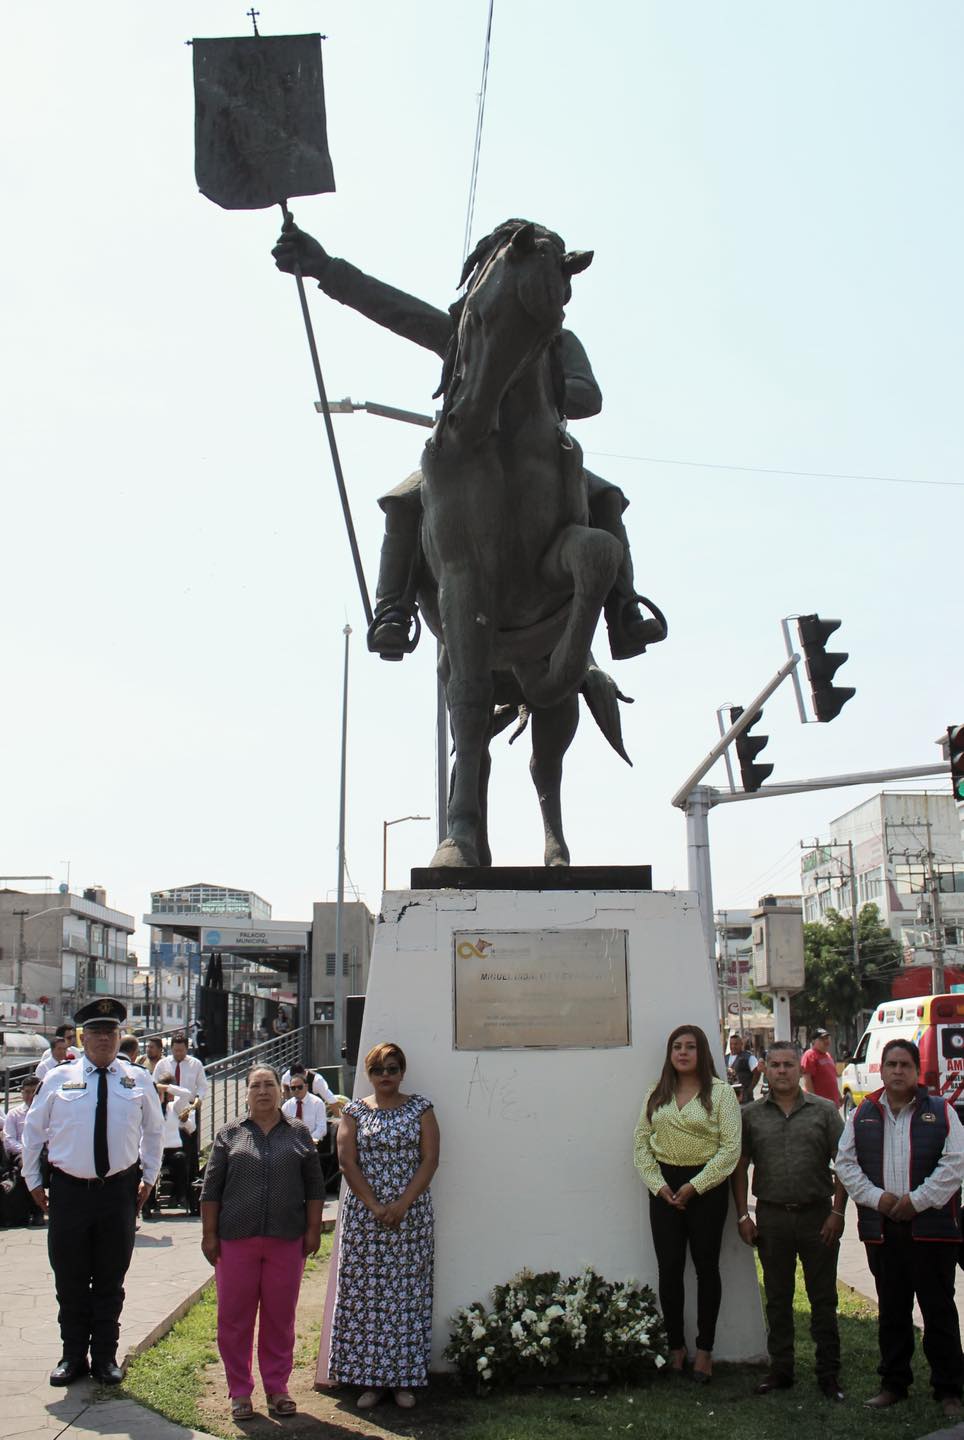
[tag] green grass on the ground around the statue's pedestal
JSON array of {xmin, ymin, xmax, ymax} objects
[{"xmin": 124, "ymin": 1236, "xmax": 944, "ymax": 1440}]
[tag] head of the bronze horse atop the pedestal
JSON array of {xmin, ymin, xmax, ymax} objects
[{"xmin": 439, "ymin": 220, "xmax": 592, "ymax": 446}]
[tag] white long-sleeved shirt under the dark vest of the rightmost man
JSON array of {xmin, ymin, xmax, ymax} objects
[{"xmin": 834, "ymin": 1090, "xmax": 964, "ymax": 1214}]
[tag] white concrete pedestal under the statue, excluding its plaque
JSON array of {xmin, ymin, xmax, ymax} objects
[{"xmin": 356, "ymin": 890, "xmax": 765, "ymax": 1368}]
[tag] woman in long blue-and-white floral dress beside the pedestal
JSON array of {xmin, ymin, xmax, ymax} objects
[{"xmin": 329, "ymin": 1044, "xmax": 438, "ymax": 1410}]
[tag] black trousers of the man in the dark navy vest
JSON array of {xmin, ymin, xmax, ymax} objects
[{"xmin": 866, "ymin": 1220, "xmax": 964, "ymax": 1400}]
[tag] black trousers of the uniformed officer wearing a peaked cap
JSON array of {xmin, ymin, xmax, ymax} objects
[{"xmin": 48, "ymin": 1165, "xmax": 140, "ymax": 1364}]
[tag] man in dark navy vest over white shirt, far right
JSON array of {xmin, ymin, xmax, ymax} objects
[{"xmin": 836, "ymin": 1040, "xmax": 964, "ymax": 1417}]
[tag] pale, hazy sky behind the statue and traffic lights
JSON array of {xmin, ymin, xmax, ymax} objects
[{"xmin": 0, "ymin": 0, "xmax": 964, "ymax": 961}]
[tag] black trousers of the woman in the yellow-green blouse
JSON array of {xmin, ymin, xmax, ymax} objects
[{"xmin": 650, "ymin": 1165, "xmax": 729, "ymax": 1351}]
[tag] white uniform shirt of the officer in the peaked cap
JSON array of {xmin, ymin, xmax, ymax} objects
[{"xmin": 23, "ymin": 1056, "xmax": 164, "ymax": 1189}]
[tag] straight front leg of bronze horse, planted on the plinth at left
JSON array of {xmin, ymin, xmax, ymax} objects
[{"xmin": 432, "ymin": 572, "xmax": 494, "ymax": 867}]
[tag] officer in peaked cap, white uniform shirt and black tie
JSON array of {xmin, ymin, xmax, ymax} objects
[{"xmin": 23, "ymin": 998, "xmax": 163, "ymax": 1385}]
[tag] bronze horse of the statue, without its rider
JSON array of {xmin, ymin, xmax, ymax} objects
[{"xmin": 418, "ymin": 223, "xmax": 624, "ymax": 865}]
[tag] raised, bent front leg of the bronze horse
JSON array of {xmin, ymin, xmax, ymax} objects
[{"xmin": 514, "ymin": 526, "xmax": 622, "ymax": 708}]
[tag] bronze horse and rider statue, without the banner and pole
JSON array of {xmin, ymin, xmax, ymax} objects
[{"xmin": 272, "ymin": 220, "xmax": 667, "ymax": 865}]
